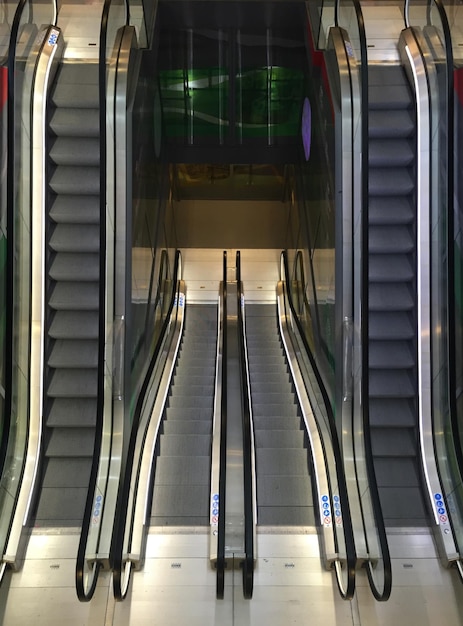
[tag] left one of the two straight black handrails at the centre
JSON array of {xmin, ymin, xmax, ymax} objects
[{"xmin": 216, "ymin": 251, "xmax": 227, "ymax": 600}]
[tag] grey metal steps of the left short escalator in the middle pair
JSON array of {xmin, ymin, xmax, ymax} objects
[{"xmin": 150, "ymin": 304, "xmax": 217, "ymax": 526}]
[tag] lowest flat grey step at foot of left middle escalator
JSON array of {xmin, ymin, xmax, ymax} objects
[{"xmin": 151, "ymin": 484, "xmax": 211, "ymax": 525}]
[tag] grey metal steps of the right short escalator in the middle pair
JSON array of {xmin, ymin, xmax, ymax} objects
[{"xmin": 246, "ymin": 304, "xmax": 315, "ymax": 526}]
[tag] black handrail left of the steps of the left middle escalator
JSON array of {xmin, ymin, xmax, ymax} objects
[{"xmin": 111, "ymin": 250, "xmax": 180, "ymax": 601}]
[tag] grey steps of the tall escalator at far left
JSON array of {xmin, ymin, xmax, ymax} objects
[{"xmin": 35, "ymin": 62, "xmax": 100, "ymax": 526}]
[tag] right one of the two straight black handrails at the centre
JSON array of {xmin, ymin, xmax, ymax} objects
[{"xmin": 236, "ymin": 250, "xmax": 255, "ymax": 599}]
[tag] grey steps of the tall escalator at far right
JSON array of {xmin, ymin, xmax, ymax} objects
[{"xmin": 368, "ymin": 65, "xmax": 428, "ymax": 526}]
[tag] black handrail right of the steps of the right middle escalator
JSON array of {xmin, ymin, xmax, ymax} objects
[{"xmin": 282, "ymin": 250, "xmax": 357, "ymax": 600}]
